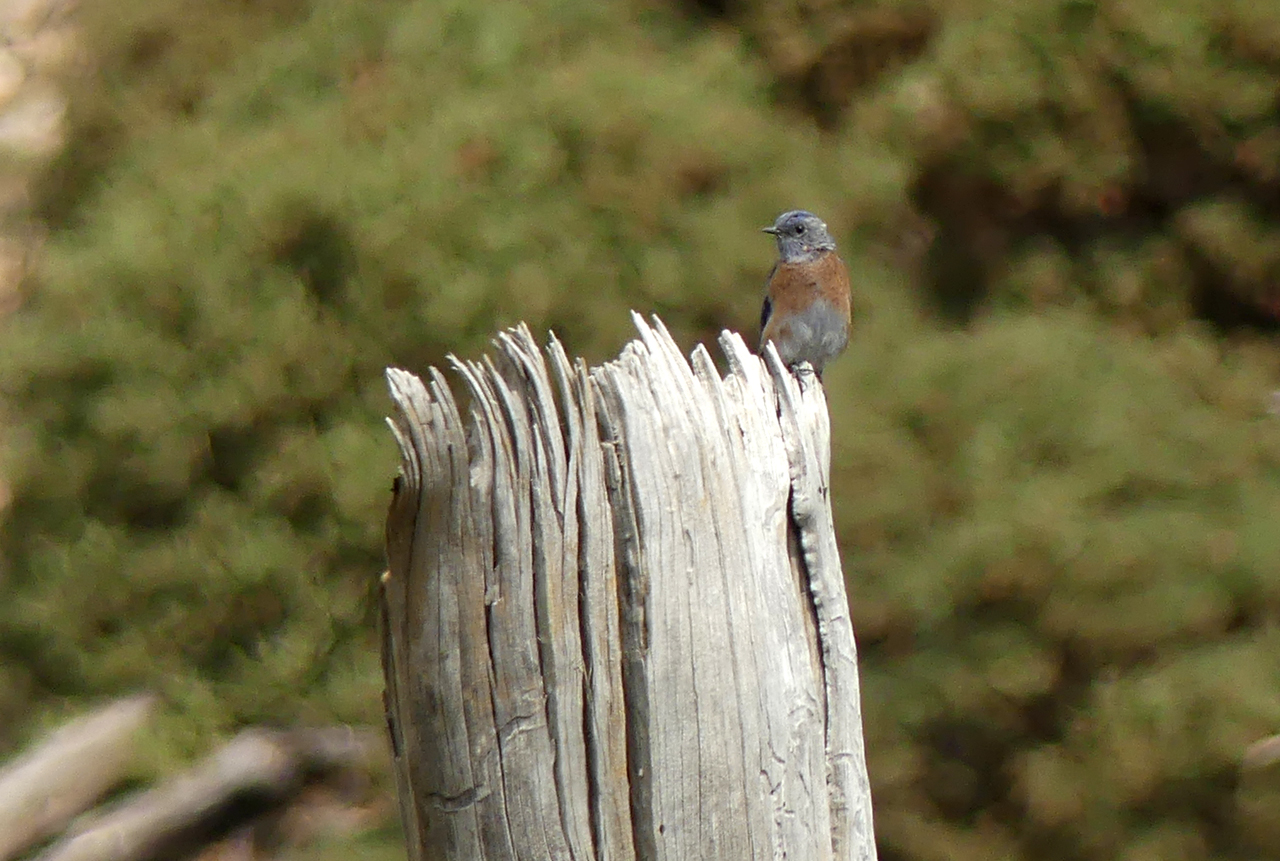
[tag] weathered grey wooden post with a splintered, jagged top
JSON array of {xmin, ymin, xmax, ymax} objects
[{"xmin": 383, "ymin": 317, "xmax": 876, "ymax": 861}]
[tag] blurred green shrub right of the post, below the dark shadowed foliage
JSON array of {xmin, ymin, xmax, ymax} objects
[{"xmin": 831, "ymin": 312, "xmax": 1280, "ymax": 858}]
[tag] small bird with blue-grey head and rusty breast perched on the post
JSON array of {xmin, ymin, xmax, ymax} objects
[{"xmin": 760, "ymin": 210, "xmax": 852, "ymax": 379}]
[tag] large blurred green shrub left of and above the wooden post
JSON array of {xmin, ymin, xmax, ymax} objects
[{"xmin": 0, "ymin": 0, "xmax": 870, "ymax": 742}]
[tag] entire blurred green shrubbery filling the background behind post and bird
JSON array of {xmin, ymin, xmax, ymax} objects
[{"xmin": 0, "ymin": 0, "xmax": 1280, "ymax": 861}]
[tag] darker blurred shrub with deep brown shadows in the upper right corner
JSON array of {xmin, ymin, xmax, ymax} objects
[{"xmin": 717, "ymin": 0, "xmax": 1280, "ymax": 331}]
